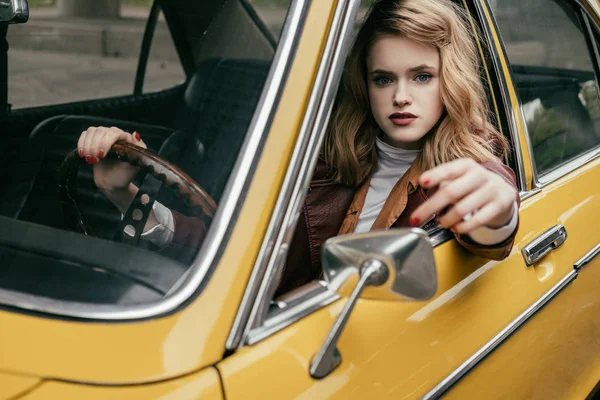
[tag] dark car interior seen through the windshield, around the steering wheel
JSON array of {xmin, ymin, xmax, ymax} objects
[{"xmin": 0, "ymin": 0, "xmax": 277, "ymax": 304}]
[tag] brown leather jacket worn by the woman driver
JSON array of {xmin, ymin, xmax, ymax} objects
[{"xmin": 165, "ymin": 159, "xmax": 519, "ymax": 296}]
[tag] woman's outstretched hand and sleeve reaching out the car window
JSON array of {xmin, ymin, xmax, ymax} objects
[{"xmin": 411, "ymin": 159, "xmax": 520, "ymax": 260}]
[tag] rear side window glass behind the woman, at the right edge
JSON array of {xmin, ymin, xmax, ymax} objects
[{"xmin": 492, "ymin": 0, "xmax": 600, "ymax": 175}]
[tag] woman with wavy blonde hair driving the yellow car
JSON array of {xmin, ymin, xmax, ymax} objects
[{"xmin": 78, "ymin": 0, "xmax": 518, "ymax": 294}]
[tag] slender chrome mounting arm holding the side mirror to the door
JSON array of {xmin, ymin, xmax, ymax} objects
[{"xmin": 309, "ymin": 258, "xmax": 390, "ymax": 379}]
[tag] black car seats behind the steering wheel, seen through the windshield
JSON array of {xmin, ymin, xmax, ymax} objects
[{"xmin": 0, "ymin": 59, "xmax": 270, "ymax": 238}]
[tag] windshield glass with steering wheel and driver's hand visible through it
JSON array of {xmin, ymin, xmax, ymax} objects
[{"xmin": 0, "ymin": 0, "xmax": 289, "ymax": 312}]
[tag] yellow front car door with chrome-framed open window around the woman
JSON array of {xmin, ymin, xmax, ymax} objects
[{"xmin": 218, "ymin": 1, "xmax": 598, "ymax": 399}]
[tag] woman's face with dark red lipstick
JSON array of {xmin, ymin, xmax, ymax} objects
[{"xmin": 367, "ymin": 35, "xmax": 443, "ymax": 149}]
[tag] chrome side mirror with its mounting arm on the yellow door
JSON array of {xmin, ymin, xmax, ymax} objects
[{"xmin": 310, "ymin": 229, "xmax": 437, "ymax": 379}]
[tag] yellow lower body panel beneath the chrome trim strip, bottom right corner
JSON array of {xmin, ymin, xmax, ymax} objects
[{"xmin": 447, "ymin": 261, "xmax": 600, "ymax": 399}]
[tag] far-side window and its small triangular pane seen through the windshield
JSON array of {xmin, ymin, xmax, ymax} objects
[{"xmin": 8, "ymin": 0, "xmax": 185, "ymax": 109}]
